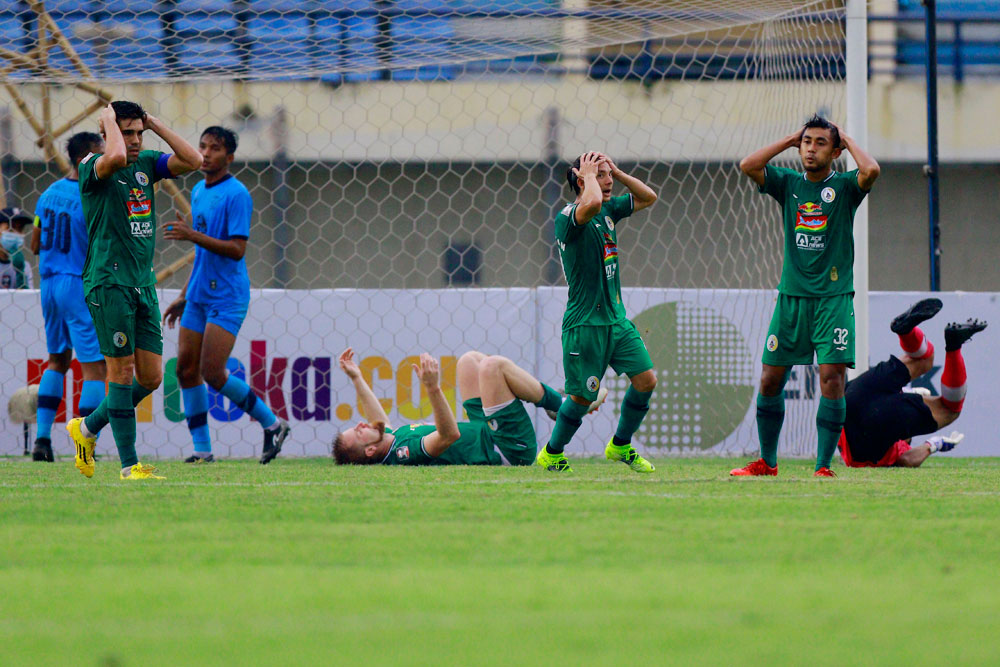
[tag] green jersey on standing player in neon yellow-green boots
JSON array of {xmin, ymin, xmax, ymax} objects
[{"xmin": 556, "ymin": 194, "xmax": 635, "ymax": 331}]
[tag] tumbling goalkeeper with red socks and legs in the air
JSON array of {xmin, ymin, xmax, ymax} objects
[{"xmin": 838, "ymin": 299, "xmax": 986, "ymax": 468}]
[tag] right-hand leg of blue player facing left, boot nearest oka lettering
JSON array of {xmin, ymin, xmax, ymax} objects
[{"xmin": 201, "ymin": 304, "xmax": 291, "ymax": 464}]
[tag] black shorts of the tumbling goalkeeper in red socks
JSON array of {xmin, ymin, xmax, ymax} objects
[{"xmin": 844, "ymin": 357, "xmax": 938, "ymax": 463}]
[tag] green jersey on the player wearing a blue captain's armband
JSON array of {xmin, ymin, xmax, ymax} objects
[{"xmin": 80, "ymin": 151, "xmax": 167, "ymax": 292}]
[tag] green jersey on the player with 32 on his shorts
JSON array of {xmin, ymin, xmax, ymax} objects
[{"xmin": 760, "ymin": 165, "xmax": 868, "ymax": 296}]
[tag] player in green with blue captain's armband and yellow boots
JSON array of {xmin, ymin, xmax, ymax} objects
[{"xmin": 66, "ymin": 101, "xmax": 201, "ymax": 480}]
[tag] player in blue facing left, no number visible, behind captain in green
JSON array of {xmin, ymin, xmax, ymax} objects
[{"xmin": 163, "ymin": 126, "xmax": 290, "ymax": 464}]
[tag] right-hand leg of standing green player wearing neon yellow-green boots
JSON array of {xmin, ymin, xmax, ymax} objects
[{"xmin": 604, "ymin": 320, "xmax": 656, "ymax": 472}]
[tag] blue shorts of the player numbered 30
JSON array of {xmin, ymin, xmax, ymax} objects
[{"xmin": 41, "ymin": 273, "xmax": 104, "ymax": 363}]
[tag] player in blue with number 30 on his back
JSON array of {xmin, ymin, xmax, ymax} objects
[{"xmin": 31, "ymin": 132, "xmax": 107, "ymax": 462}]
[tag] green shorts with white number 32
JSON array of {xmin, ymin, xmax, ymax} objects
[{"xmin": 762, "ymin": 293, "xmax": 854, "ymax": 368}]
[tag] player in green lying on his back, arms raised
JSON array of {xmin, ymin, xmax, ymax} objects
[{"xmin": 333, "ymin": 348, "xmax": 606, "ymax": 465}]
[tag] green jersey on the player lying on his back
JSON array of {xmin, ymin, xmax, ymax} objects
[{"xmin": 382, "ymin": 422, "xmax": 502, "ymax": 466}]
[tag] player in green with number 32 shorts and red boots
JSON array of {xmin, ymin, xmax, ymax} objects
[{"xmin": 729, "ymin": 116, "xmax": 879, "ymax": 477}]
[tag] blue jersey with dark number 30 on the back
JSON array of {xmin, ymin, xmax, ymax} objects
[{"xmin": 35, "ymin": 178, "xmax": 87, "ymax": 278}]
